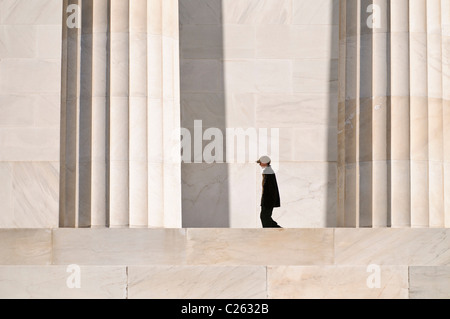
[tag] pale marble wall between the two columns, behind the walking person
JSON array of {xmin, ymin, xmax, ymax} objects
[{"xmin": 180, "ymin": 0, "xmax": 339, "ymax": 228}]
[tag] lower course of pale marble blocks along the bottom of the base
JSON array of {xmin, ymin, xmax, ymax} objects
[{"xmin": 0, "ymin": 265, "xmax": 450, "ymax": 299}]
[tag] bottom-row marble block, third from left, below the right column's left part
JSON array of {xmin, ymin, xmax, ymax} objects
[{"xmin": 267, "ymin": 266, "xmax": 408, "ymax": 299}]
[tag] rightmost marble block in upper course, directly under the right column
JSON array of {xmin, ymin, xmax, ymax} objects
[{"xmin": 335, "ymin": 228, "xmax": 450, "ymax": 266}]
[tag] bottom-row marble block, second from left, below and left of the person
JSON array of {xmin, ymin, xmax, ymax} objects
[{"xmin": 128, "ymin": 266, "xmax": 267, "ymax": 299}]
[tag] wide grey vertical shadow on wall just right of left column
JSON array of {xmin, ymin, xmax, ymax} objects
[{"xmin": 179, "ymin": 0, "xmax": 231, "ymax": 228}]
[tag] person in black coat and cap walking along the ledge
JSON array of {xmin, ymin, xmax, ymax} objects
[{"xmin": 257, "ymin": 156, "xmax": 281, "ymax": 228}]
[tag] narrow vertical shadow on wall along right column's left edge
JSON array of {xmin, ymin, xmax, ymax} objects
[{"xmin": 325, "ymin": 0, "xmax": 340, "ymax": 227}]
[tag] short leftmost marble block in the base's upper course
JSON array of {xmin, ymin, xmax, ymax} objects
[{"xmin": 0, "ymin": 229, "xmax": 52, "ymax": 265}]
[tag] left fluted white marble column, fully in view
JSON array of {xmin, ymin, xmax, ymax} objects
[{"xmin": 60, "ymin": 0, "xmax": 181, "ymax": 228}]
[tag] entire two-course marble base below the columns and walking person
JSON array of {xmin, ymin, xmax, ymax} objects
[{"xmin": 0, "ymin": 228, "xmax": 450, "ymax": 299}]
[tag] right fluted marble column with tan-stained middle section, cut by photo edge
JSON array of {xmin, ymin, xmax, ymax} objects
[{"xmin": 338, "ymin": 0, "xmax": 450, "ymax": 227}]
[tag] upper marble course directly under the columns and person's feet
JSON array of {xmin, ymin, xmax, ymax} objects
[{"xmin": 0, "ymin": 228, "xmax": 450, "ymax": 267}]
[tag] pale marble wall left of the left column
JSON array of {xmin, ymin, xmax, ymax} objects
[{"xmin": 0, "ymin": 0, "xmax": 62, "ymax": 228}]
